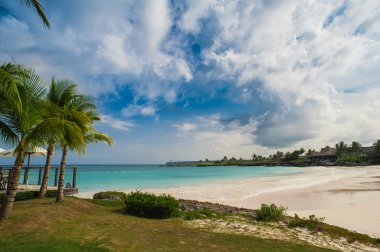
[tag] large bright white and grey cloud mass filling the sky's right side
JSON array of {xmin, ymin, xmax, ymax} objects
[{"xmin": 183, "ymin": 1, "xmax": 380, "ymax": 147}]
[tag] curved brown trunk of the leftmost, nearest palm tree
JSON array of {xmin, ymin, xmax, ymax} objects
[{"xmin": 0, "ymin": 137, "xmax": 25, "ymax": 220}]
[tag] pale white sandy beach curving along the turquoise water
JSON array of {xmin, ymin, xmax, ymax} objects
[{"xmin": 79, "ymin": 166, "xmax": 380, "ymax": 237}]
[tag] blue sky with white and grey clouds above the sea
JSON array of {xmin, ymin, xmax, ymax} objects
[{"xmin": 0, "ymin": 0, "xmax": 380, "ymax": 164}]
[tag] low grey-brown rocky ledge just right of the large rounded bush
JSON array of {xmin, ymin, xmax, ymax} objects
[{"xmin": 178, "ymin": 199, "xmax": 256, "ymax": 218}]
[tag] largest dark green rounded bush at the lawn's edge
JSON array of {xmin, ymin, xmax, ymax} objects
[{"xmin": 125, "ymin": 191, "xmax": 179, "ymax": 219}]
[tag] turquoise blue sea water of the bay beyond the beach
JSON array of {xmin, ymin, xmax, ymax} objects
[{"xmin": 21, "ymin": 165, "xmax": 305, "ymax": 192}]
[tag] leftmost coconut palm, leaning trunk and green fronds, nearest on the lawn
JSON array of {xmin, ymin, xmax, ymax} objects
[{"xmin": 0, "ymin": 63, "xmax": 84, "ymax": 219}]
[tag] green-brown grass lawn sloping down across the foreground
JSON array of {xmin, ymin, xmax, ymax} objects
[{"xmin": 0, "ymin": 198, "xmax": 331, "ymax": 251}]
